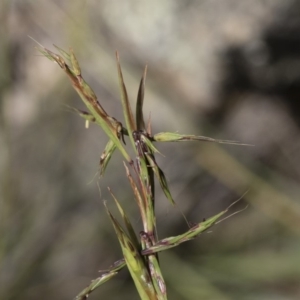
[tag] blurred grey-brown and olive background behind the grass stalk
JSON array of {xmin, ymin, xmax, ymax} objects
[{"xmin": 0, "ymin": 0, "xmax": 300, "ymax": 300}]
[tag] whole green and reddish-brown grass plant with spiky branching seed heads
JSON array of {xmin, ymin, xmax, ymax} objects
[{"xmin": 34, "ymin": 45, "xmax": 245, "ymax": 300}]
